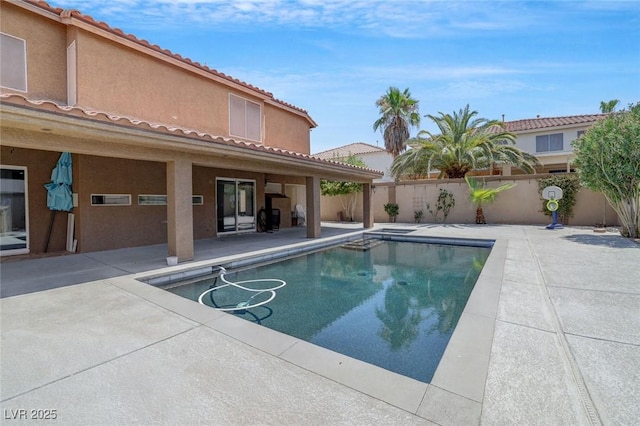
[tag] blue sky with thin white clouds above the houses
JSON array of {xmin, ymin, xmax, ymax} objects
[{"xmin": 49, "ymin": 0, "xmax": 640, "ymax": 153}]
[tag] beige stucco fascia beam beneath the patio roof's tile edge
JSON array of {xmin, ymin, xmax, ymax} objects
[{"xmin": 0, "ymin": 98, "xmax": 382, "ymax": 182}]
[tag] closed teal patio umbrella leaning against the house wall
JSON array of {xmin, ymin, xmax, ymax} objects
[{"xmin": 44, "ymin": 152, "xmax": 73, "ymax": 253}]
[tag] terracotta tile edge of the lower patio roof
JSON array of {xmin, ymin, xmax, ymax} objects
[{"xmin": 0, "ymin": 93, "xmax": 383, "ymax": 175}]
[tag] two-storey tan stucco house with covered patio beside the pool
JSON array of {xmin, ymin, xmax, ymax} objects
[{"xmin": 0, "ymin": 0, "xmax": 381, "ymax": 261}]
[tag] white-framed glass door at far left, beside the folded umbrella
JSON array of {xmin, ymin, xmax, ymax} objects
[{"xmin": 0, "ymin": 166, "xmax": 29, "ymax": 256}]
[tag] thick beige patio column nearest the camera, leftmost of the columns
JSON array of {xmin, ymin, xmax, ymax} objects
[{"xmin": 167, "ymin": 160, "xmax": 194, "ymax": 262}]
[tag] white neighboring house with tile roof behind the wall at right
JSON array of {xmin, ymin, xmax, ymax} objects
[{"xmin": 502, "ymin": 114, "xmax": 606, "ymax": 175}]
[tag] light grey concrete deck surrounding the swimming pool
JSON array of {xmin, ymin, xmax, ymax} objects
[{"xmin": 0, "ymin": 224, "xmax": 640, "ymax": 425}]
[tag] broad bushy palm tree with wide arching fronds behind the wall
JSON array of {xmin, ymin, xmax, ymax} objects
[{"xmin": 391, "ymin": 105, "xmax": 540, "ymax": 179}]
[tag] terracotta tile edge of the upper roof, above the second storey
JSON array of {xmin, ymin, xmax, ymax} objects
[{"xmin": 24, "ymin": 0, "xmax": 317, "ymax": 127}]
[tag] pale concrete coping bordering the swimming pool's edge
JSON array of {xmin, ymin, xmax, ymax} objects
[{"xmin": 114, "ymin": 231, "xmax": 507, "ymax": 423}]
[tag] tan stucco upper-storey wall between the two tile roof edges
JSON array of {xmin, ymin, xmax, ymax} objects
[{"xmin": 0, "ymin": 2, "xmax": 311, "ymax": 154}]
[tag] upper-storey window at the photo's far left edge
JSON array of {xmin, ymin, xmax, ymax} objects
[{"xmin": 0, "ymin": 33, "xmax": 27, "ymax": 92}]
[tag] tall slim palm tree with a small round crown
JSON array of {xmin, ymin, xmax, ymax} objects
[{"xmin": 373, "ymin": 87, "xmax": 420, "ymax": 158}]
